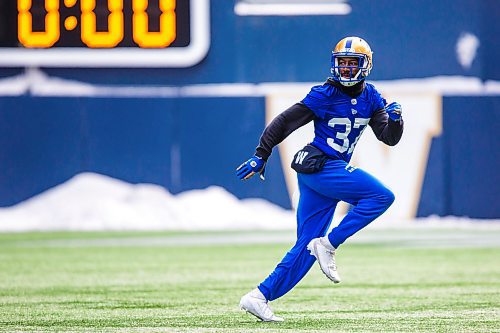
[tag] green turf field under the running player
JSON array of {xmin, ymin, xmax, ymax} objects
[{"xmin": 0, "ymin": 233, "xmax": 500, "ymax": 332}]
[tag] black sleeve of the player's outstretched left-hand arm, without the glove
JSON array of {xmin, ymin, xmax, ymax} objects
[{"xmin": 255, "ymin": 103, "xmax": 315, "ymax": 161}]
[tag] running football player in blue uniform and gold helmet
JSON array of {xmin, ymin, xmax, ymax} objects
[{"xmin": 237, "ymin": 37, "xmax": 403, "ymax": 321}]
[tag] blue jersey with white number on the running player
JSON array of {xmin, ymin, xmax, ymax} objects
[{"xmin": 302, "ymin": 83, "xmax": 386, "ymax": 162}]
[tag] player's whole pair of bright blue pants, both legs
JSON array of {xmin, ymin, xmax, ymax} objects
[{"xmin": 259, "ymin": 160, "xmax": 394, "ymax": 301}]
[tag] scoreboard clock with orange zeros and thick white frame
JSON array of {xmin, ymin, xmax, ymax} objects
[{"xmin": 0, "ymin": 0, "xmax": 210, "ymax": 67}]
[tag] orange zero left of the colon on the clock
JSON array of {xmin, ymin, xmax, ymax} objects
[{"xmin": 17, "ymin": 0, "xmax": 60, "ymax": 48}]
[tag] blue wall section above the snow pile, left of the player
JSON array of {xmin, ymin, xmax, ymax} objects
[{"xmin": 0, "ymin": 96, "xmax": 290, "ymax": 207}]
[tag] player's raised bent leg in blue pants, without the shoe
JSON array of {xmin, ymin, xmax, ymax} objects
[{"xmin": 303, "ymin": 161, "xmax": 394, "ymax": 248}]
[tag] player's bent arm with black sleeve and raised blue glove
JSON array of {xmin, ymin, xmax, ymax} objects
[{"xmin": 369, "ymin": 103, "xmax": 404, "ymax": 146}]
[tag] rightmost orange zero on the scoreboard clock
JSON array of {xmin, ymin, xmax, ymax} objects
[{"xmin": 132, "ymin": 0, "xmax": 177, "ymax": 48}]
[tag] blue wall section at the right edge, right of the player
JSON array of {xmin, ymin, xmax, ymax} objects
[{"xmin": 418, "ymin": 96, "xmax": 500, "ymax": 218}]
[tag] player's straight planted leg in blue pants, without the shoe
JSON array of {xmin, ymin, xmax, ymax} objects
[{"xmin": 259, "ymin": 177, "xmax": 338, "ymax": 301}]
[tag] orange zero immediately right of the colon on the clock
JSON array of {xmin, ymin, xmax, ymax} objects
[{"xmin": 81, "ymin": 0, "xmax": 123, "ymax": 48}]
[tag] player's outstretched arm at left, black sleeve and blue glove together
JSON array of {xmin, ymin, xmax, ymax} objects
[{"xmin": 236, "ymin": 103, "xmax": 315, "ymax": 179}]
